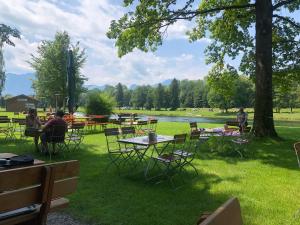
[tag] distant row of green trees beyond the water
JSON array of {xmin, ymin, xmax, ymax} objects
[{"xmin": 90, "ymin": 76, "xmax": 254, "ymax": 111}]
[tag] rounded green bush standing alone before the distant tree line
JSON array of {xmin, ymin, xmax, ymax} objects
[{"xmin": 86, "ymin": 92, "xmax": 115, "ymax": 115}]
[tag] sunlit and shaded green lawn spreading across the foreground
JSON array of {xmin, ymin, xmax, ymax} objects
[{"xmin": 0, "ymin": 122, "xmax": 300, "ymax": 225}]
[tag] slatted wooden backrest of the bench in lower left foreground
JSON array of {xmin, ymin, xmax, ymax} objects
[{"xmin": 0, "ymin": 160, "xmax": 79, "ymax": 224}]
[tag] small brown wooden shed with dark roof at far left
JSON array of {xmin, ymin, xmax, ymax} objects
[{"xmin": 6, "ymin": 95, "xmax": 39, "ymax": 112}]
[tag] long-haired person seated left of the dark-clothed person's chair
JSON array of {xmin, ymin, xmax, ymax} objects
[{"xmin": 25, "ymin": 109, "xmax": 42, "ymax": 150}]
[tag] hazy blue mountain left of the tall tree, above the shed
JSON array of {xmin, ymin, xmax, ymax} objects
[{"xmin": 2, "ymin": 73, "xmax": 34, "ymax": 96}]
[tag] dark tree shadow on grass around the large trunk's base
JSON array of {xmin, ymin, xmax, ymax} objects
[{"xmin": 195, "ymin": 128, "xmax": 300, "ymax": 170}]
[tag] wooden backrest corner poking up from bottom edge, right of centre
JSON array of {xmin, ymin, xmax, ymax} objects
[{"xmin": 197, "ymin": 198, "xmax": 243, "ymax": 225}]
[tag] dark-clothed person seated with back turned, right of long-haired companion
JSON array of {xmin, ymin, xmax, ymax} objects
[{"xmin": 41, "ymin": 110, "xmax": 68, "ymax": 152}]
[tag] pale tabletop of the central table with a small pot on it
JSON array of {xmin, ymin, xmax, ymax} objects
[{"xmin": 118, "ymin": 135, "xmax": 174, "ymax": 146}]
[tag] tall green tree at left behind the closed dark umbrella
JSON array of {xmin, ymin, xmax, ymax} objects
[{"xmin": 30, "ymin": 31, "xmax": 86, "ymax": 107}]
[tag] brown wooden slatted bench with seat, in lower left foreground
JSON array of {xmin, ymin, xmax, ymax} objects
[{"xmin": 0, "ymin": 160, "xmax": 79, "ymax": 225}]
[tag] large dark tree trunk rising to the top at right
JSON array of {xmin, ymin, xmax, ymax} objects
[{"xmin": 253, "ymin": 0, "xmax": 277, "ymax": 137}]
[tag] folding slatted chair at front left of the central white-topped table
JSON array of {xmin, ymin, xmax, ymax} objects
[{"xmin": 104, "ymin": 128, "xmax": 135, "ymax": 172}]
